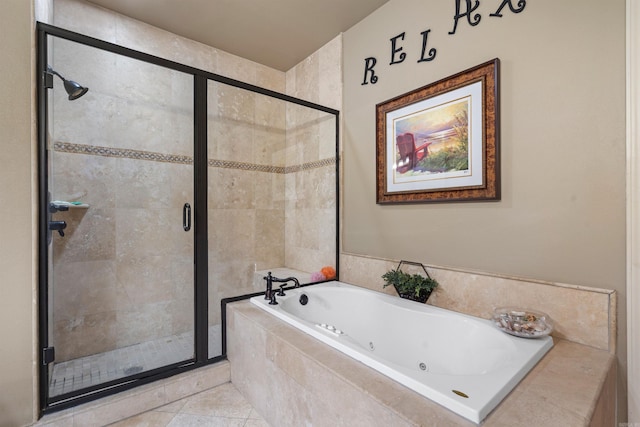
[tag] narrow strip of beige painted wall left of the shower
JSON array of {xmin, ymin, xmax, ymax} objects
[{"xmin": 0, "ymin": 0, "xmax": 35, "ymax": 426}]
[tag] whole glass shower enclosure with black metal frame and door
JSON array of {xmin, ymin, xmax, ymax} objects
[{"xmin": 38, "ymin": 23, "xmax": 338, "ymax": 411}]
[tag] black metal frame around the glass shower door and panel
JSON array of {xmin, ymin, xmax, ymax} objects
[{"xmin": 36, "ymin": 22, "xmax": 340, "ymax": 415}]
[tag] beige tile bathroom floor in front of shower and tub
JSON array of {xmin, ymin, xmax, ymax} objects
[{"xmin": 110, "ymin": 383, "xmax": 269, "ymax": 427}]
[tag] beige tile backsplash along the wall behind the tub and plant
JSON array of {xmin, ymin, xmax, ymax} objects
[{"xmin": 340, "ymin": 253, "xmax": 615, "ymax": 351}]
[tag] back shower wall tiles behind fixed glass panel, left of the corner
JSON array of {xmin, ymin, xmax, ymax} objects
[{"xmin": 208, "ymin": 82, "xmax": 286, "ymax": 325}]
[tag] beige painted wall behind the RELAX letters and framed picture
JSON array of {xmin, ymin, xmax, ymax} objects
[{"xmin": 343, "ymin": 0, "xmax": 626, "ymax": 422}]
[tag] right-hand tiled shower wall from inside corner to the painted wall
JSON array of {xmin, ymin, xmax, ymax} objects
[{"xmin": 285, "ymin": 35, "xmax": 342, "ymax": 278}]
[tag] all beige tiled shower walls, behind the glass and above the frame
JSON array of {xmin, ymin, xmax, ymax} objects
[{"xmin": 50, "ymin": 0, "xmax": 341, "ymax": 361}]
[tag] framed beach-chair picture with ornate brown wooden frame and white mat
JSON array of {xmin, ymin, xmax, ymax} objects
[{"xmin": 376, "ymin": 59, "xmax": 500, "ymax": 204}]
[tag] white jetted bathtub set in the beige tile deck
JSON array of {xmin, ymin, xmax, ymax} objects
[{"xmin": 251, "ymin": 282, "xmax": 553, "ymax": 423}]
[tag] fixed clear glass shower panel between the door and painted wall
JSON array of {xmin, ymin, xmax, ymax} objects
[{"xmin": 208, "ymin": 82, "xmax": 336, "ymax": 325}]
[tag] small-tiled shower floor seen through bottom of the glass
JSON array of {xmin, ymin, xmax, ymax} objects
[{"xmin": 49, "ymin": 325, "xmax": 222, "ymax": 397}]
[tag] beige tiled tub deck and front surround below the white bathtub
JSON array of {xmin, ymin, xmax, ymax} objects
[{"xmin": 227, "ymin": 301, "xmax": 616, "ymax": 426}]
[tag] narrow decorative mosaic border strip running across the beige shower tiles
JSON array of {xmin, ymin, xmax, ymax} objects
[{"xmin": 53, "ymin": 141, "xmax": 337, "ymax": 174}]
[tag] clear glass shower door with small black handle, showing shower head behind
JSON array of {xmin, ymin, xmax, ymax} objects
[{"xmin": 47, "ymin": 36, "xmax": 194, "ymax": 400}]
